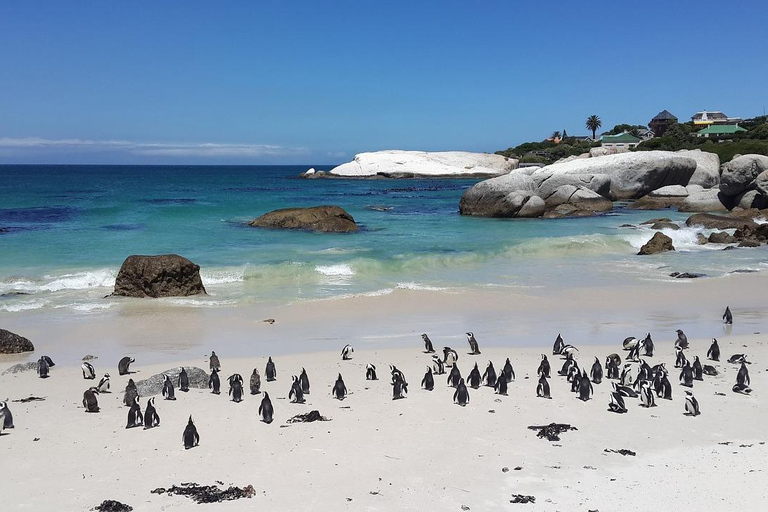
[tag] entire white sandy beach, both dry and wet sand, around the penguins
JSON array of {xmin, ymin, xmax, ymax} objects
[{"xmin": 0, "ymin": 276, "xmax": 768, "ymax": 511}]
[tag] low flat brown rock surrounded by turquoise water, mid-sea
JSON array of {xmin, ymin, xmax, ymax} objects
[{"xmin": 248, "ymin": 206, "xmax": 357, "ymax": 233}]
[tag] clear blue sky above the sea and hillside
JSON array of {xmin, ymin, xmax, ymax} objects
[{"xmin": 0, "ymin": 0, "xmax": 768, "ymax": 164}]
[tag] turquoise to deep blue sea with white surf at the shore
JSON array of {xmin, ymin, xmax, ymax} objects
[{"xmin": 0, "ymin": 165, "xmax": 768, "ymax": 314}]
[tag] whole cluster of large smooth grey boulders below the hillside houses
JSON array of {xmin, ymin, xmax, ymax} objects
[{"xmin": 459, "ymin": 150, "xmax": 768, "ymax": 217}]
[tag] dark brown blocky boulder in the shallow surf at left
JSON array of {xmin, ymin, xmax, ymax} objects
[{"xmin": 112, "ymin": 254, "xmax": 205, "ymax": 298}]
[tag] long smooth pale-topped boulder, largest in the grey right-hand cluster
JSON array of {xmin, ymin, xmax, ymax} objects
[{"xmin": 538, "ymin": 151, "xmax": 696, "ymax": 199}]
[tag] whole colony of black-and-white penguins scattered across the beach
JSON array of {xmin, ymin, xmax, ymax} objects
[{"xmin": 0, "ymin": 307, "xmax": 752, "ymax": 449}]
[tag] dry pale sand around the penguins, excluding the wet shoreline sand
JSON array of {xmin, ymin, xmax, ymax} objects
[{"xmin": 0, "ymin": 330, "xmax": 768, "ymax": 511}]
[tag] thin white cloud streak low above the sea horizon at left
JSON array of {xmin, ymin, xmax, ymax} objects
[{"xmin": 0, "ymin": 137, "xmax": 306, "ymax": 157}]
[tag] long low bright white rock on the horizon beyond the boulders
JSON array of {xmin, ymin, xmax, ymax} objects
[{"xmin": 328, "ymin": 150, "xmax": 518, "ymax": 178}]
